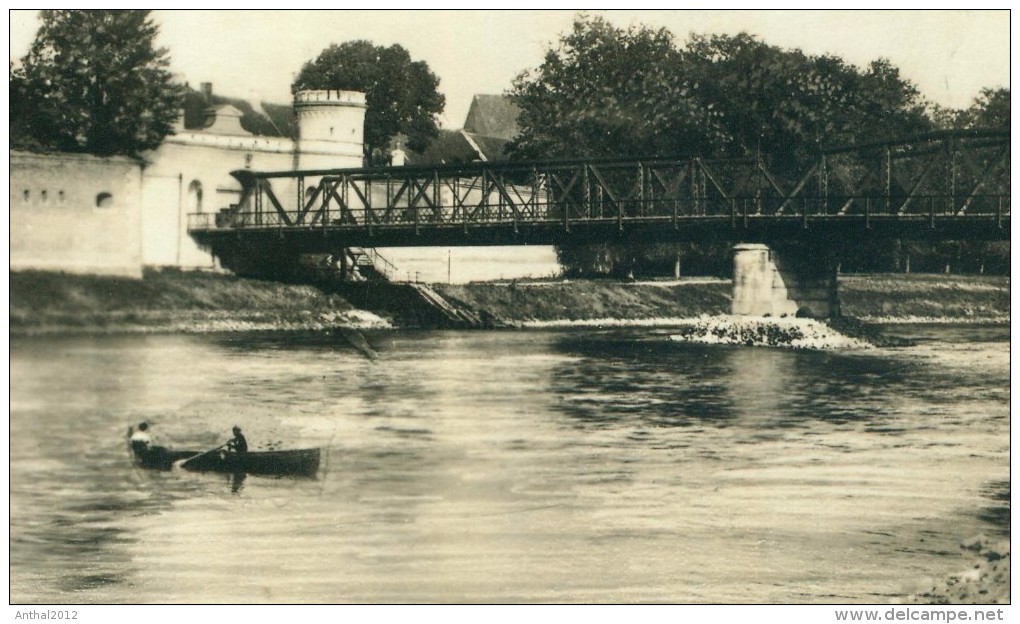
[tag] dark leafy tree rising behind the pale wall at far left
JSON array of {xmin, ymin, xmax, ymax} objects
[{"xmin": 10, "ymin": 10, "xmax": 183, "ymax": 156}]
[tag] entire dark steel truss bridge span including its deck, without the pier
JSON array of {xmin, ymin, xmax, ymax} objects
[{"xmin": 188, "ymin": 131, "xmax": 1010, "ymax": 261}]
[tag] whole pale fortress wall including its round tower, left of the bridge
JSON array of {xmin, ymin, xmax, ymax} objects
[{"xmin": 10, "ymin": 91, "xmax": 365, "ymax": 275}]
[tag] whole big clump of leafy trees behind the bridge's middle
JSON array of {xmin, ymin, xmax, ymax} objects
[{"xmin": 508, "ymin": 15, "xmax": 932, "ymax": 273}]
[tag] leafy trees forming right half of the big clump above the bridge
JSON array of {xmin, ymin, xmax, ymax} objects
[{"xmin": 685, "ymin": 34, "xmax": 931, "ymax": 175}]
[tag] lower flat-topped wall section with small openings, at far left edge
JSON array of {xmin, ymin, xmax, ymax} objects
[{"xmin": 10, "ymin": 152, "xmax": 142, "ymax": 277}]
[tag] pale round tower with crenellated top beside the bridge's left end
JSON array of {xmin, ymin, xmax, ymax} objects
[{"xmin": 294, "ymin": 90, "xmax": 366, "ymax": 170}]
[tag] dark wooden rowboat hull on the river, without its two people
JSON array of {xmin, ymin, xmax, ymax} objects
[{"xmin": 134, "ymin": 447, "xmax": 319, "ymax": 476}]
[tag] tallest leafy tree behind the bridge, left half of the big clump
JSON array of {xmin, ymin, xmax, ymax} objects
[{"xmin": 508, "ymin": 15, "xmax": 723, "ymax": 159}]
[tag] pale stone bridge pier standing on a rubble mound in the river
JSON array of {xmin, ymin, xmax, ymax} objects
[{"xmin": 731, "ymin": 243, "xmax": 839, "ymax": 318}]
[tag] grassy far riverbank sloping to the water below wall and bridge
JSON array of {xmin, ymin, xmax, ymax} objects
[{"xmin": 10, "ymin": 270, "xmax": 1010, "ymax": 334}]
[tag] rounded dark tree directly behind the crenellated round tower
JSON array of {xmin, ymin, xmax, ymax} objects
[{"xmin": 291, "ymin": 41, "xmax": 446, "ymax": 163}]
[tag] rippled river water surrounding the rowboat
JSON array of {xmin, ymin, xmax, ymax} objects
[{"xmin": 10, "ymin": 326, "xmax": 1010, "ymax": 604}]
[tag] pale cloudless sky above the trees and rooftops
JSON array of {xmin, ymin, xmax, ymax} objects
[{"xmin": 10, "ymin": 10, "xmax": 1010, "ymax": 128}]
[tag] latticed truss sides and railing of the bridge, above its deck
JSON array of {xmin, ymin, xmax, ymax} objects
[{"xmin": 189, "ymin": 131, "xmax": 1010, "ymax": 237}]
